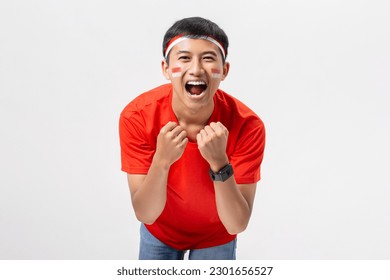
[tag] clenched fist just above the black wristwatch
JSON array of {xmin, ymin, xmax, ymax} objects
[{"xmin": 196, "ymin": 122, "xmax": 229, "ymax": 172}]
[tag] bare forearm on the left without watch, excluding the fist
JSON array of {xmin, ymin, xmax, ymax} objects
[{"xmin": 132, "ymin": 160, "xmax": 169, "ymax": 224}]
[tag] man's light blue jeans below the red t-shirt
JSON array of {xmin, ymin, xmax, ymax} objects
[{"xmin": 139, "ymin": 224, "xmax": 237, "ymax": 260}]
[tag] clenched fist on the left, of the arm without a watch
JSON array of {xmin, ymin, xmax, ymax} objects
[{"xmin": 154, "ymin": 122, "xmax": 188, "ymax": 168}]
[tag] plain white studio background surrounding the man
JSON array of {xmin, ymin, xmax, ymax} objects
[{"xmin": 0, "ymin": 0, "xmax": 390, "ymax": 259}]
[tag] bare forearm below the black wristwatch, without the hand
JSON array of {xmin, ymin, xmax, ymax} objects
[{"xmin": 214, "ymin": 176, "xmax": 251, "ymax": 234}]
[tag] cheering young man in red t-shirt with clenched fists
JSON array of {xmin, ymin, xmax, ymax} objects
[{"xmin": 119, "ymin": 17, "xmax": 265, "ymax": 259}]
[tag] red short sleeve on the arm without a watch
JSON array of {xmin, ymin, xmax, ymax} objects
[{"xmin": 119, "ymin": 112, "xmax": 155, "ymax": 174}]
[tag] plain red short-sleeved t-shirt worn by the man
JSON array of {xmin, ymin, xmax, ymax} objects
[{"xmin": 119, "ymin": 84, "xmax": 265, "ymax": 250}]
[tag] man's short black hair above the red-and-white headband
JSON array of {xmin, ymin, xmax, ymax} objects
[{"xmin": 162, "ymin": 17, "xmax": 229, "ymax": 63}]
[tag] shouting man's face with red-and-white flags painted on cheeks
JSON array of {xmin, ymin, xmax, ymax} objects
[{"xmin": 162, "ymin": 39, "xmax": 229, "ymax": 112}]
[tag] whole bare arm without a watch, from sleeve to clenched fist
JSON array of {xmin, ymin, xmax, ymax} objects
[{"xmin": 127, "ymin": 122, "xmax": 188, "ymax": 224}]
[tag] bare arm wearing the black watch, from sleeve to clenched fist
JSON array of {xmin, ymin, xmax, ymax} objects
[{"xmin": 197, "ymin": 122, "xmax": 256, "ymax": 234}]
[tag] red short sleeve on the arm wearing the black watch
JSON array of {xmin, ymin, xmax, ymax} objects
[{"xmin": 230, "ymin": 120, "xmax": 265, "ymax": 184}]
